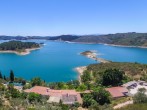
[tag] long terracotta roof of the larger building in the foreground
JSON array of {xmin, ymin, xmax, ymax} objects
[{"xmin": 24, "ymin": 86, "xmax": 82, "ymax": 104}]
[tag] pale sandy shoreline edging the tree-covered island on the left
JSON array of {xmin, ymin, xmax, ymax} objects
[{"xmin": 0, "ymin": 47, "xmax": 40, "ymax": 56}]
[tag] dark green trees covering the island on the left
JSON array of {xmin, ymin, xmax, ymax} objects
[{"xmin": 0, "ymin": 41, "xmax": 40, "ymax": 52}]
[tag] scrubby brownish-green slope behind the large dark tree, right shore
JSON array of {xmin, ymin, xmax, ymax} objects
[{"xmin": 87, "ymin": 62, "xmax": 147, "ymax": 80}]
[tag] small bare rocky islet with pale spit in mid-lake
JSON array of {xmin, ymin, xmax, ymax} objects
[{"xmin": 80, "ymin": 51, "xmax": 110, "ymax": 63}]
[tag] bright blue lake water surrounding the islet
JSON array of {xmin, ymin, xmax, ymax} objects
[{"xmin": 0, "ymin": 41, "xmax": 147, "ymax": 82}]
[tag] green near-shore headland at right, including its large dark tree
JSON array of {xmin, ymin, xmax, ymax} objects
[{"xmin": 81, "ymin": 62, "xmax": 147, "ymax": 90}]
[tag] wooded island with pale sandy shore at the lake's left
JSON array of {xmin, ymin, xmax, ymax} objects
[{"xmin": 0, "ymin": 41, "xmax": 41, "ymax": 55}]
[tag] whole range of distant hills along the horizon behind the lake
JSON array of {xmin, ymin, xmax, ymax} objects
[{"xmin": 0, "ymin": 32, "xmax": 147, "ymax": 47}]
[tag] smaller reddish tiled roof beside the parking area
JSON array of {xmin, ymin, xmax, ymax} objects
[{"xmin": 106, "ymin": 87, "xmax": 128, "ymax": 98}]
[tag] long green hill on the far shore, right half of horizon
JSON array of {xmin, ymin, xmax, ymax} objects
[{"xmin": 73, "ymin": 32, "xmax": 147, "ymax": 46}]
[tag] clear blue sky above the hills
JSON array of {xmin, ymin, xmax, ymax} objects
[{"xmin": 0, "ymin": 0, "xmax": 147, "ymax": 36}]
